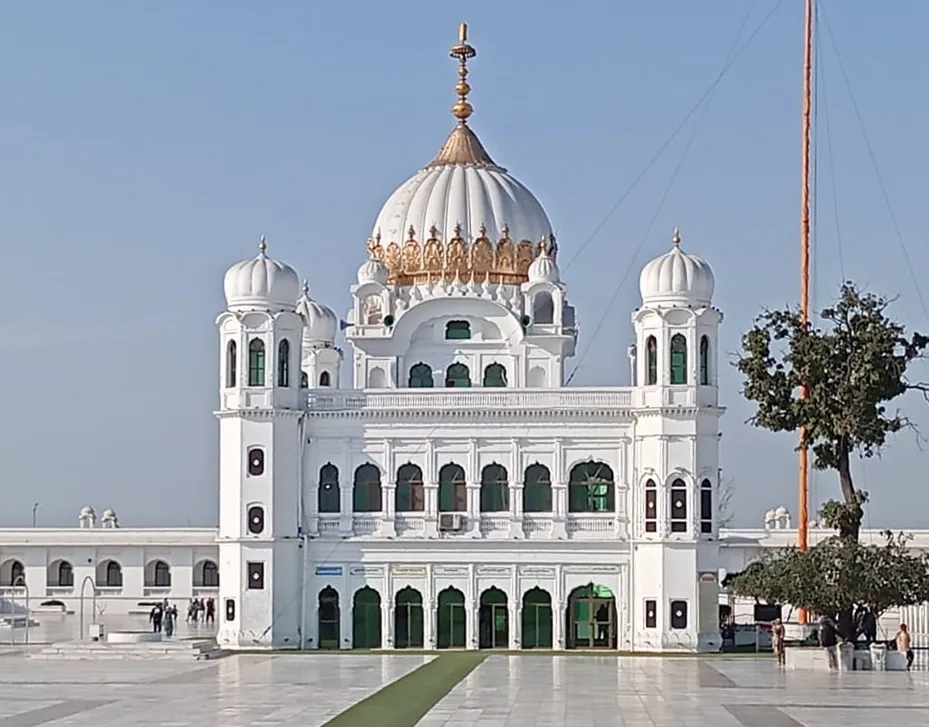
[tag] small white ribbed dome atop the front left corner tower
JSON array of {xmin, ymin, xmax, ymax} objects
[{"xmin": 223, "ymin": 237, "xmax": 300, "ymax": 311}]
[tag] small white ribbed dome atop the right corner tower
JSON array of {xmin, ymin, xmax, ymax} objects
[{"xmin": 639, "ymin": 229, "xmax": 716, "ymax": 308}]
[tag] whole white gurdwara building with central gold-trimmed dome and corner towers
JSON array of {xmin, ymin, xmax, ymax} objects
[{"xmin": 217, "ymin": 33, "xmax": 723, "ymax": 650}]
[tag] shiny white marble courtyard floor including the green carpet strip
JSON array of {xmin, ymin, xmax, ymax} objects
[{"xmin": 0, "ymin": 650, "xmax": 929, "ymax": 727}]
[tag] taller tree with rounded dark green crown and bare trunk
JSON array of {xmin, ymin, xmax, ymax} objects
[{"xmin": 737, "ymin": 283, "xmax": 929, "ymax": 541}]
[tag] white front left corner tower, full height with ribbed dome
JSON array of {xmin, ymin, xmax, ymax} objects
[{"xmin": 216, "ymin": 237, "xmax": 305, "ymax": 649}]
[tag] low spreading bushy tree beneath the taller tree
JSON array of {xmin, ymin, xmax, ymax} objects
[{"xmin": 727, "ymin": 531, "xmax": 929, "ymax": 640}]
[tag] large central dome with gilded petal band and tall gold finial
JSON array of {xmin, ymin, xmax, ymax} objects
[{"xmin": 359, "ymin": 24, "xmax": 555, "ymax": 285}]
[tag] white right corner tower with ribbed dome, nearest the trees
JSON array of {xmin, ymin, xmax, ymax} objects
[{"xmin": 630, "ymin": 230, "xmax": 723, "ymax": 651}]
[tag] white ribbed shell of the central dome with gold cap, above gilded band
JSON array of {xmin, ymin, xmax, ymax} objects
[{"xmin": 373, "ymin": 123, "xmax": 552, "ymax": 246}]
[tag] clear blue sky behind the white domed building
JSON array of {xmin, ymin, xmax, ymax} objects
[{"xmin": 0, "ymin": 0, "xmax": 929, "ymax": 527}]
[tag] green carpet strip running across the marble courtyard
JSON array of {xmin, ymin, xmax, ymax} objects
[{"xmin": 323, "ymin": 652, "xmax": 486, "ymax": 727}]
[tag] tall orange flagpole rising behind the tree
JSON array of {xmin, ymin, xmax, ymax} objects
[{"xmin": 797, "ymin": 0, "xmax": 813, "ymax": 624}]
